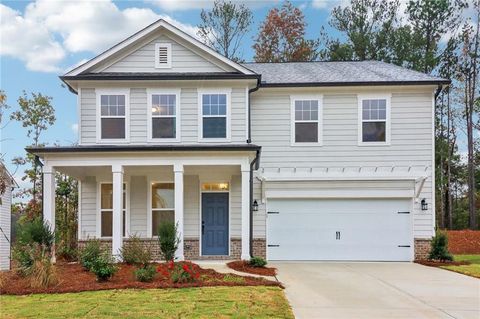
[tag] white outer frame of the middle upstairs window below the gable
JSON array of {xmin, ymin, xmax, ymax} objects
[{"xmin": 147, "ymin": 88, "xmax": 182, "ymax": 143}]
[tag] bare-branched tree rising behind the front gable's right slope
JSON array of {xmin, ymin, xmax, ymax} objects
[{"xmin": 198, "ymin": 0, "xmax": 252, "ymax": 61}]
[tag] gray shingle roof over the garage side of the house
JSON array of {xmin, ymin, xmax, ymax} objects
[{"xmin": 243, "ymin": 61, "xmax": 450, "ymax": 86}]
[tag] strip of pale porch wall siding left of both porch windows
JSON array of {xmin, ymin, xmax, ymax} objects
[{"xmin": 79, "ymin": 176, "xmax": 97, "ymax": 239}]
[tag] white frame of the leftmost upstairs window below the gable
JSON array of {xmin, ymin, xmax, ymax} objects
[{"xmin": 95, "ymin": 89, "xmax": 130, "ymax": 144}]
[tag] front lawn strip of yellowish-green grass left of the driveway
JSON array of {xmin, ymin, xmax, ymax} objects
[{"xmin": 0, "ymin": 286, "xmax": 293, "ymax": 319}]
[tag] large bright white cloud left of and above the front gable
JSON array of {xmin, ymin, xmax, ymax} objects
[{"xmin": 0, "ymin": 0, "xmax": 197, "ymax": 72}]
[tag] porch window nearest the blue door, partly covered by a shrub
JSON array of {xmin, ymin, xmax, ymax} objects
[{"xmin": 151, "ymin": 182, "xmax": 175, "ymax": 236}]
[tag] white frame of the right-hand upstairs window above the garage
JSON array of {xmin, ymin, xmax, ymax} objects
[{"xmin": 357, "ymin": 93, "xmax": 392, "ymax": 146}]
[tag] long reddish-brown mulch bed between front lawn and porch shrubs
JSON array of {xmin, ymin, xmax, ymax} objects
[{"xmin": 0, "ymin": 263, "xmax": 282, "ymax": 295}]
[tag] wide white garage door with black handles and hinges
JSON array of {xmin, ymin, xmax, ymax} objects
[{"xmin": 267, "ymin": 199, "xmax": 413, "ymax": 261}]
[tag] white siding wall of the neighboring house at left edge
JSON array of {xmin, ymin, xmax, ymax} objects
[{"xmin": 0, "ymin": 185, "xmax": 12, "ymax": 270}]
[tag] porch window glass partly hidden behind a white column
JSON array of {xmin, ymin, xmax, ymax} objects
[{"xmin": 100, "ymin": 183, "xmax": 127, "ymax": 237}]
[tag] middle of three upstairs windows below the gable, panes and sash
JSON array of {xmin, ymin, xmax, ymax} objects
[{"xmin": 148, "ymin": 90, "xmax": 180, "ymax": 141}]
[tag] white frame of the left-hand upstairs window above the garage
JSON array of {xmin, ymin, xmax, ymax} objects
[{"xmin": 290, "ymin": 94, "xmax": 323, "ymax": 146}]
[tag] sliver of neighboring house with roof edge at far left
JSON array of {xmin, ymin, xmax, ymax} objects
[{"xmin": 0, "ymin": 164, "xmax": 18, "ymax": 270}]
